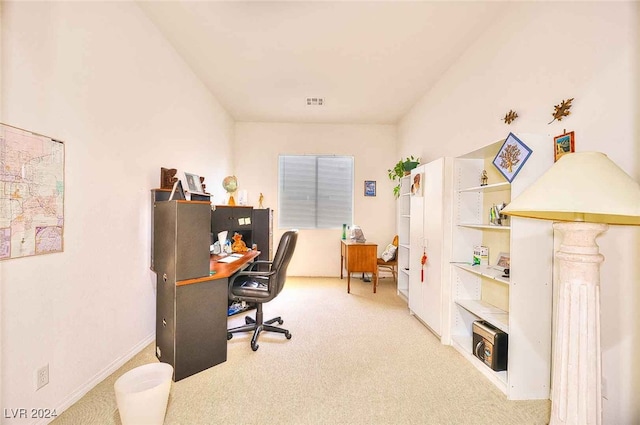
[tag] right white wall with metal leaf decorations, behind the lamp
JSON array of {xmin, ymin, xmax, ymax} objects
[{"xmin": 398, "ymin": 2, "xmax": 640, "ymax": 425}]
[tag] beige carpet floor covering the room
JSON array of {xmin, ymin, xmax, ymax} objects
[{"xmin": 52, "ymin": 278, "xmax": 550, "ymax": 425}]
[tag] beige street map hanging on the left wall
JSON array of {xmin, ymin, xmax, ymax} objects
[{"xmin": 0, "ymin": 124, "xmax": 64, "ymax": 260}]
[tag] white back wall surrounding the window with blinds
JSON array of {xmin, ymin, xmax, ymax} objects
[{"xmin": 234, "ymin": 122, "xmax": 399, "ymax": 274}]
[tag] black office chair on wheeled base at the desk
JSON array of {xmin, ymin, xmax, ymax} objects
[{"xmin": 227, "ymin": 230, "xmax": 298, "ymax": 351}]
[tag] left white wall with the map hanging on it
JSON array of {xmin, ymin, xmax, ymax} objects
[{"xmin": 0, "ymin": 2, "xmax": 234, "ymax": 424}]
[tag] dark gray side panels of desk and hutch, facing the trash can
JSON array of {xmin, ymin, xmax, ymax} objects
[{"xmin": 151, "ymin": 190, "xmax": 228, "ymax": 381}]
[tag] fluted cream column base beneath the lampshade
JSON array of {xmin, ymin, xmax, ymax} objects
[{"xmin": 550, "ymin": 222, "xmax": 609, "ymax": 425}]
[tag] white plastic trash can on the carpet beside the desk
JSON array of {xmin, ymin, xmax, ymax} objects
[{"xmin": 114, "ymin": 363, "xmax": 173, "ymax": 425}]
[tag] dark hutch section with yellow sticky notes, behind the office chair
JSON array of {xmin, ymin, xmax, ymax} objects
[{"xmin": 211, "ymin": 205, "xmax": 273, "ymax": 261}]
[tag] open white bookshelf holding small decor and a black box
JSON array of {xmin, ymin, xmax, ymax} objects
[{"xmin": 450, "ymin": 135, "xmax": 553, "ymax": 400}]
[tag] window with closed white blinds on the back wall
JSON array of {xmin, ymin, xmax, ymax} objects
[{"xmin": 278, "ymin": 155, "xmax": 353, "ymax": 229}]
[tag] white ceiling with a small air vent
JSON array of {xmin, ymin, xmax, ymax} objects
[{"xmin": 139, "ymin": 1, "xmax": 505, "ymax": 124}]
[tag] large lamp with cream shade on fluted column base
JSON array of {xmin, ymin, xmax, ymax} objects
[{"xmin": 501, "ymin": 152, "xmax": 640, "ymax": 425}]
